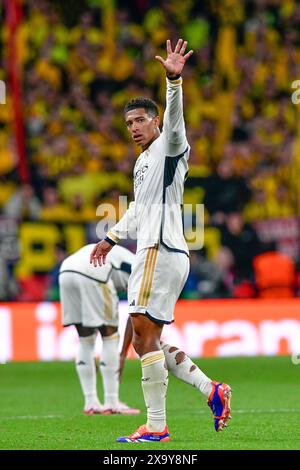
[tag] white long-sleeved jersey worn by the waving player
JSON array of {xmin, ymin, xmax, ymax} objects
[{"xmin": 107, "ymin": 78, "xmax": 190, "ymax": 255}]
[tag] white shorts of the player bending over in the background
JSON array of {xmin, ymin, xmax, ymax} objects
[{"xmin": 59, "ymin": 271, "xmax": 119, "ymax": 328}]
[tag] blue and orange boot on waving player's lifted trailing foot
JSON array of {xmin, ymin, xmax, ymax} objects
[{"xmin": 207, "ymin": 382, "xmax": 231, "ymax": 432}]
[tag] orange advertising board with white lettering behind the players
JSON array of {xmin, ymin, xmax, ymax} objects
[{"xmin": 0, "ymin": 299, "xmax": 300, "ymax": 363}]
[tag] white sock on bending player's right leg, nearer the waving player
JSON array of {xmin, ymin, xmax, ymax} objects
[{"xmin": 100, "ymin": 333, "xmax": 119, "ymax": 408}]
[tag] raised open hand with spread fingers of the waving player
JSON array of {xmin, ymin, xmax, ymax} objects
[{"xmin": 155, "ymin": 39, "xmax": 193, "ymax": 78}]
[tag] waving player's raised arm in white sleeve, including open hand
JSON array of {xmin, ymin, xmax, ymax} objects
[{"xmin": 155, "ymin": 39, "xmax": 193, "ymax": 153}]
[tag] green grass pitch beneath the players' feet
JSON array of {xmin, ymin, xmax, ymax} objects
[{"xmin": 0, "ymin": 357, "xmax": 300, "ymax": 450}]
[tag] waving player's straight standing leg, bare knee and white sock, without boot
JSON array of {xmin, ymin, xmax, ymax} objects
[{"xmin": 131, "ymin": 314, "xmax": 168, "ymax": 432}]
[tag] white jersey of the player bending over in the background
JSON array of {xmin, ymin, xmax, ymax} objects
[{"xmin": 60, "ymin": 243, "xmax": 134, "ymax": 291}]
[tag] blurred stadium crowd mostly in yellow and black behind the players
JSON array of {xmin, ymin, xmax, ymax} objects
[{"xmin": 0, "ymin": 0, "xmax": 300, "ymax": 300}]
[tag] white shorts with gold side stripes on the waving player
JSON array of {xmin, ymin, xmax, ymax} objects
[{"xmin": 128, "ymin": 245, "xmax": 190, "ymax": 323}]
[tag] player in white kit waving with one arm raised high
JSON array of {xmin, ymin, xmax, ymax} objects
[{"xmin": 90, "ymin": 39, "xmax": 231, "ymax": 442}]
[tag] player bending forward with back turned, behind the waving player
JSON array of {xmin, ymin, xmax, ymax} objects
[{"xmin": 59, "ymin": 244, "xmax": 140, "ymax": 415}]
